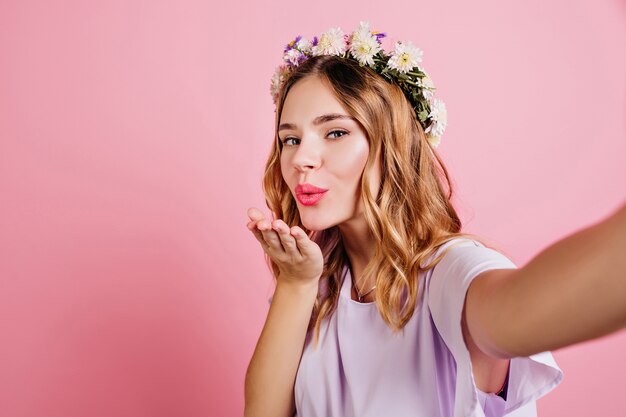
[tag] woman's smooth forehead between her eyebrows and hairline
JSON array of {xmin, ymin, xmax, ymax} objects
[{"xmin": 280, "ymin": 76, "xmax": 349, "ymax": 124}]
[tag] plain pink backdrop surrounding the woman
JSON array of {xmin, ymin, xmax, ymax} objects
[{"xmin": 0, "ymin": 0, "xmax": 626, "ymax": 417}]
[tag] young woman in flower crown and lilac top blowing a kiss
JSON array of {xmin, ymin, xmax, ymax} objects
[{"xmin": 245, "ymin": 23, "xmax": 626, "ymax": 417}]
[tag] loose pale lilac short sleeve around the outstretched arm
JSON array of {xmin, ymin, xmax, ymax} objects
[{"xmin": 426, "ymin": 239, "xmax": 563, "ymax": 417}]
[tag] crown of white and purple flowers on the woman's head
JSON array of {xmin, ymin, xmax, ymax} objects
[{"xmin": 270, "ymin": 22, "xmax": 448, "ymax": 147}]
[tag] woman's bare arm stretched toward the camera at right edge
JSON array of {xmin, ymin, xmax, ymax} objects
[{"xmin": 465, "ymin": 205, "xmax": 626, "ymax": 358}]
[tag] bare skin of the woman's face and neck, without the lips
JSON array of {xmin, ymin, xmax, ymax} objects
[{"xmin": 278, "ymin": 77, "xmax": 382, "ymax": 293}]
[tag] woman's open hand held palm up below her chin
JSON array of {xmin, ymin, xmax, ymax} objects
[{"xmin": 248, "ymin": 207, "xmax": 324, "ymax": 287}]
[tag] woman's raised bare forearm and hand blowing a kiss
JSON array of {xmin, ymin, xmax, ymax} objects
[{"xmin": 244, "ymin": 208, "xmax": 323, "ymax": 417}]
